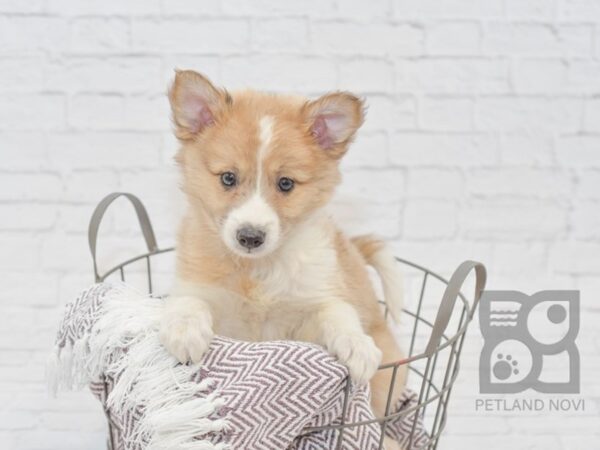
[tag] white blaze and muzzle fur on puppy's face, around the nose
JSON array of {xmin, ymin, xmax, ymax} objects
[{"xmin": 223, "ymin": 116, "xmax": 280, "ymax": 256}]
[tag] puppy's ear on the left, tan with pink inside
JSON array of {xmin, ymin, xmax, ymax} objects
[{"xmin": 169, "ymin": 70, "xmax": 230, "ymax": 141}]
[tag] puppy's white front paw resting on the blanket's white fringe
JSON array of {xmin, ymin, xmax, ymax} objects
[{"xmin": 160, "ymin": 300, "xmax": 214, "ymax": 363}]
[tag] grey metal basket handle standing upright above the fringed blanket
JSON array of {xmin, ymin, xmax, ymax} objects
[{"xmin": 88, "ymin": 192, "xmax": 158, "ymax": 282}]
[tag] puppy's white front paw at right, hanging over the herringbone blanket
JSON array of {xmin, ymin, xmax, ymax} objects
[{"xmin": 328, "ymin": 333, "xmax": 381, "ymax": 384}]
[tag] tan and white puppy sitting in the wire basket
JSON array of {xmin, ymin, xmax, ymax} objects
[{"xmin": 160, "ymin": 71, "xmax": 404, "ymax": 415}]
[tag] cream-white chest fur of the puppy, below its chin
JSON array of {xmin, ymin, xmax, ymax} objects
[{"xmin": 172, "ymin": 217, "xmax": 342, "ymax": 341}]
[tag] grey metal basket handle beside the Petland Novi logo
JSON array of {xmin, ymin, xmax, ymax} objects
[{"xmin": 425, "ymin": 261, "xmax": 486, "ymax": 356}]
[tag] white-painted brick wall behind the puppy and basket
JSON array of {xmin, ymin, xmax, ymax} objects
[{"xmin": 0, "ymin": 0, "xmax": 600, "ymax": 450}]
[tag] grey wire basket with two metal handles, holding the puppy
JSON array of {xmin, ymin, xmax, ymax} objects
[{"xmin": 88, "ymin": 193, "xmax": 486, "ymax": 450}]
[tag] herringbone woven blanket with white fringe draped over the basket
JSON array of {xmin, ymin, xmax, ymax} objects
[{"xmin": 48, "ymin": 283, "xmax": 428, "ymax": 450}]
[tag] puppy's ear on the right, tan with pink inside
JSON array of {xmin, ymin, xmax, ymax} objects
[{"xmin": 304, "ymin": 92, "xmax": 364, "ymax": 158}]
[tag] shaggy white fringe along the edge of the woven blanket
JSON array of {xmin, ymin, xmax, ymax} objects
[{"xmin": 46, "ymin": 284, "xmax": 229, "ymax": 450}]
